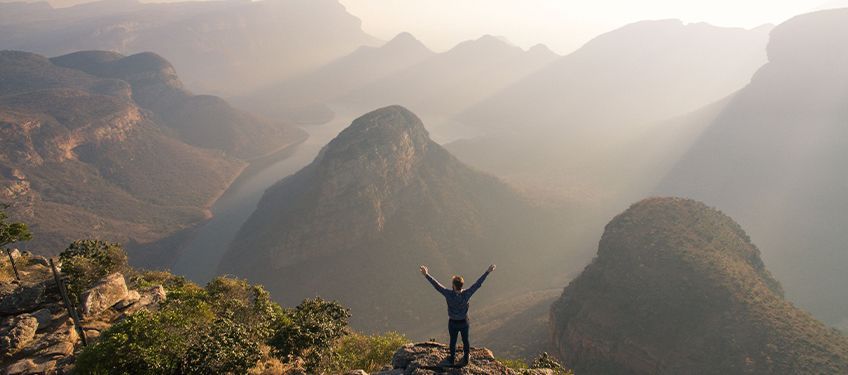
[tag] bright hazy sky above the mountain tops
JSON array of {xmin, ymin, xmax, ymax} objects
[{"xmin": 340, "ymin": 0, "xmax": 836, "ymax": 53}]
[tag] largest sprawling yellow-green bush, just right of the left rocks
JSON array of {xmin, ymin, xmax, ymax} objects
[{"xmin": 76, "ymin": 272, "xmax": 283, "ymax": 374}]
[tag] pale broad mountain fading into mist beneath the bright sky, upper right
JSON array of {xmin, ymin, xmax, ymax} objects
[{"xmin": 460, "ymin": 20, "xmax": 770, "ymax": 132}]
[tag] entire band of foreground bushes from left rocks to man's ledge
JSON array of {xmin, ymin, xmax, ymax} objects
[{"xmin": 61, "ymin": 245, "xmax": 407, "ymax": 374}]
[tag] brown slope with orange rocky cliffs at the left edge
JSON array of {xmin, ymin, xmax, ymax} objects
[{"xmin": 0, "ymin": 51, "xmax": 284, "ymax": 261}]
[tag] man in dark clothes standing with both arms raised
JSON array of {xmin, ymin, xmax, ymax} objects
[{"xmin": 421, "ymin": 264, "xmax": 495, "ymax": 366}]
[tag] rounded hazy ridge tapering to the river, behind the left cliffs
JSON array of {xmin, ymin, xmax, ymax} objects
[{"xmin": 50, "ymin": 51, "xmax": 303, "ymax": 159}]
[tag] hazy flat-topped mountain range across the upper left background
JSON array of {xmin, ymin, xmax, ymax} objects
[{"xmin": 0, "ymin": 0, "xmax": 376, "ymax": 94}]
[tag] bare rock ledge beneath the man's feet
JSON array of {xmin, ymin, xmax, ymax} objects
[{"xmin": 375, "ymin": 342, "xmax": 516, "ymax": 375}]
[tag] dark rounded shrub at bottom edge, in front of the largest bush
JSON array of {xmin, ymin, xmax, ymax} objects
[{"xmin": 181, "ymin": 318, "xmax": 262, "ymax": 375}]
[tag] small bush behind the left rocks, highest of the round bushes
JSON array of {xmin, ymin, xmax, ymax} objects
[{"xmin": 59, "ymin": 240, "xmax": 127, "ymax": 299}]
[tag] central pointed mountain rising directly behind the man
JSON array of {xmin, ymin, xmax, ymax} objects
[{"xmin": 220, "ymin": 106, "xmax": 568, "ymax": 335}]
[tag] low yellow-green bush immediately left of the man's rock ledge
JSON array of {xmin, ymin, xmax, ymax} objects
[{"xmin": 322, "ymin": 332, "xmax": 409, "ymax": 374}]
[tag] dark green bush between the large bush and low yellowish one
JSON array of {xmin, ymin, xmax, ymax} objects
[{"xmin": 269, "ymin": 298, "xmax": 350, "ymax": 372}]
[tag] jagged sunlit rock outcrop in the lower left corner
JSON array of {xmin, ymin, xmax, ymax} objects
[{"xmin": 0, "ymin": 256, "xmax": 166, "ymax": 375}]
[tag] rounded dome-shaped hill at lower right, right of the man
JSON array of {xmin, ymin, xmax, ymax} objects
[{"xmin": 551, "ymin": 198, "xmax": 848, "ymax": 374}]
